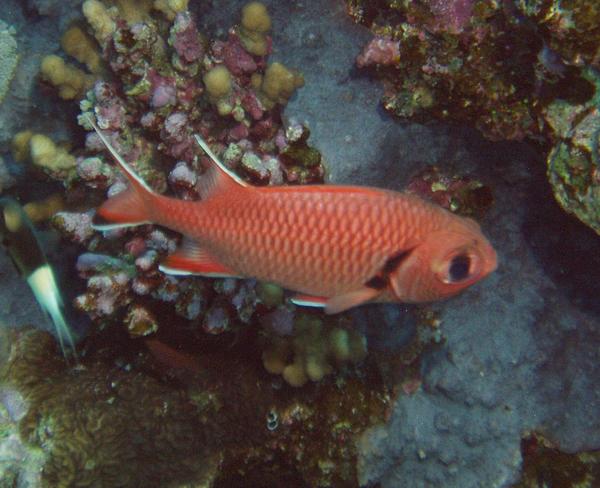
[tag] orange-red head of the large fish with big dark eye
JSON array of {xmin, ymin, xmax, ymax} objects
[{"xmin": 390, "ymin": 218, "xmax": 498, "ymax": 303}]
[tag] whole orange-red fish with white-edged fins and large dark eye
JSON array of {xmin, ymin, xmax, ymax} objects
[{"xmin": 90, "ymin": 120, "xmax": 497, "ymax": 313}]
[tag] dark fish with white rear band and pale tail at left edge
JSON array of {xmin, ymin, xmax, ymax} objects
[{"xmin": 0, "ymin": 197, "xmax": 75, "ymax": 355}]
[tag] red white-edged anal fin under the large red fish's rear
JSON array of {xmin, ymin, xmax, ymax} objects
[{"xmin": 159, "ymin": 237, "xmax": 239, "ymax": 278}]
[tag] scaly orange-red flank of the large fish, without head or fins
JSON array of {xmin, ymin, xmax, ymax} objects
[{"xmin": 155, "ymin": 187, "xmax": 438, "ymax": 296}]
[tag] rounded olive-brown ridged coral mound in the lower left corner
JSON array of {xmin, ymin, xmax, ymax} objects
[{"xmin": 0, "ymin": 331, "xmax": 218, "ymax": 486}]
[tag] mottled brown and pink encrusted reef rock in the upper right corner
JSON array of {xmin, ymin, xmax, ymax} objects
[{"xmin": 347, "ymin": 0, "xmax": 600, "ymax": 230}]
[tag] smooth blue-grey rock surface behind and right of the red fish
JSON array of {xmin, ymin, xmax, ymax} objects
[{"xmin": 204, "ymin": 0, "xmax": 600, "ymax": 488}]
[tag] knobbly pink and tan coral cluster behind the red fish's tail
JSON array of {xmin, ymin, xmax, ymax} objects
[{"xmin": 43, "ymin": 0, "xmax": 324, "ymax": 346}]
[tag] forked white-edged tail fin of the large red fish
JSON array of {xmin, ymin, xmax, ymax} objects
[{"xmin": 87, "ymin": 117, "xmax": 158, "ymax": 230}]
